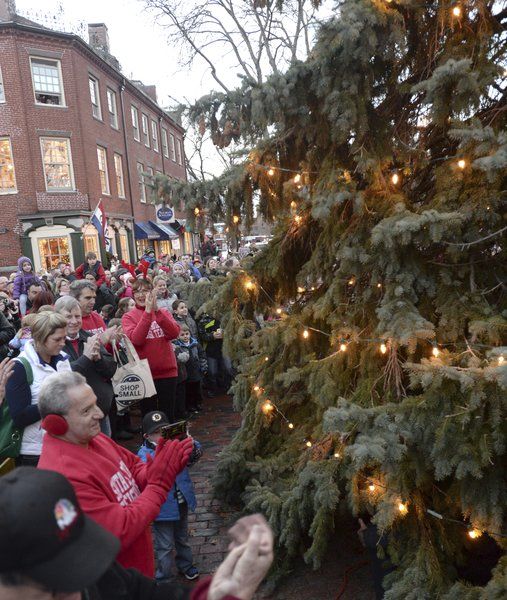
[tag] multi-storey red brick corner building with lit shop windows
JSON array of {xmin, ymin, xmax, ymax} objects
[{"xmin": 0, "ymin": 0, "xmax": 192, "ymax": 269}]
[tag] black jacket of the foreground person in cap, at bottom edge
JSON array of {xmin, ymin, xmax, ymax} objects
[{"xmin": 82, "ymin": 563, "xmax": 190, "ymax": 600}]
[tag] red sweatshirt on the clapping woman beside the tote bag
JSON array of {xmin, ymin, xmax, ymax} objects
[{"xmin": 121, "ymin": 306, "xmax": 180, "ymax": 379}]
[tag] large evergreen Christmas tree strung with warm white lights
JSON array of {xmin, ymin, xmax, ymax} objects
[{"xmin": 157, "ymin": 0, "xmax": 507, "ymax": 600}]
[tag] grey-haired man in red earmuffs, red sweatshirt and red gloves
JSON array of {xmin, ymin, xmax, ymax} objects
[{"xmin": 39, "ymin": 372, "xmax": 192, "ymax": 577}]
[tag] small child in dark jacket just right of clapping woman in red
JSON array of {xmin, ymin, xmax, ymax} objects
[{"xmin": 174, "ymin": 324, "xmax": 208, "ymax": 413}]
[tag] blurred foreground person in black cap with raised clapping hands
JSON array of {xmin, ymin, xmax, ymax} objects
[{"xmin": 0, "ymin": 467, "xmax": 273, "ymax": 600}]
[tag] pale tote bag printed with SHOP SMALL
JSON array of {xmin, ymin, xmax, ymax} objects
[{"xmin": 112, "ymin": 337, "xmax": 157, "ymax": 411}]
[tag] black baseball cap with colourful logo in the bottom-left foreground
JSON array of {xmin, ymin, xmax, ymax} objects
[{"xmin": 0, "ymin": 467, "xmax": 120, "ymax": 593}]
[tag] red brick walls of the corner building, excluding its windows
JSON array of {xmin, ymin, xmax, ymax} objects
[{"xmin": 0, "ymin": 16, "xmax": 186, "ymax": 268}]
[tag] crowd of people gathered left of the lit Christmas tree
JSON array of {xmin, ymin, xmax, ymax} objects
[{"xmin": 0, "ymin": 239, "xmax": 272, "ymax": 599}]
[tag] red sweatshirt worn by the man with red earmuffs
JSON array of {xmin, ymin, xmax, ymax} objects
[{"xmin": 38, "ymin": 433, "xmax": 167, "ymax": 577}]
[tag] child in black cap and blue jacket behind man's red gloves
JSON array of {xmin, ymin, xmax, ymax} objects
[{"xmin": 138, "ymin": 411, "xmax": 202, "ymax": 581}]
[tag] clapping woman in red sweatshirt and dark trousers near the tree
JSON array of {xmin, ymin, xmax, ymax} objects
[{"xmin": 121, "ymin": 279, "xmax": 180, "ymax": 423}]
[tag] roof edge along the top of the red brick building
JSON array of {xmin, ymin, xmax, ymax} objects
[{"xmin": 0, "ymin": 15, "xmax": 185, "ymax": 134}]
